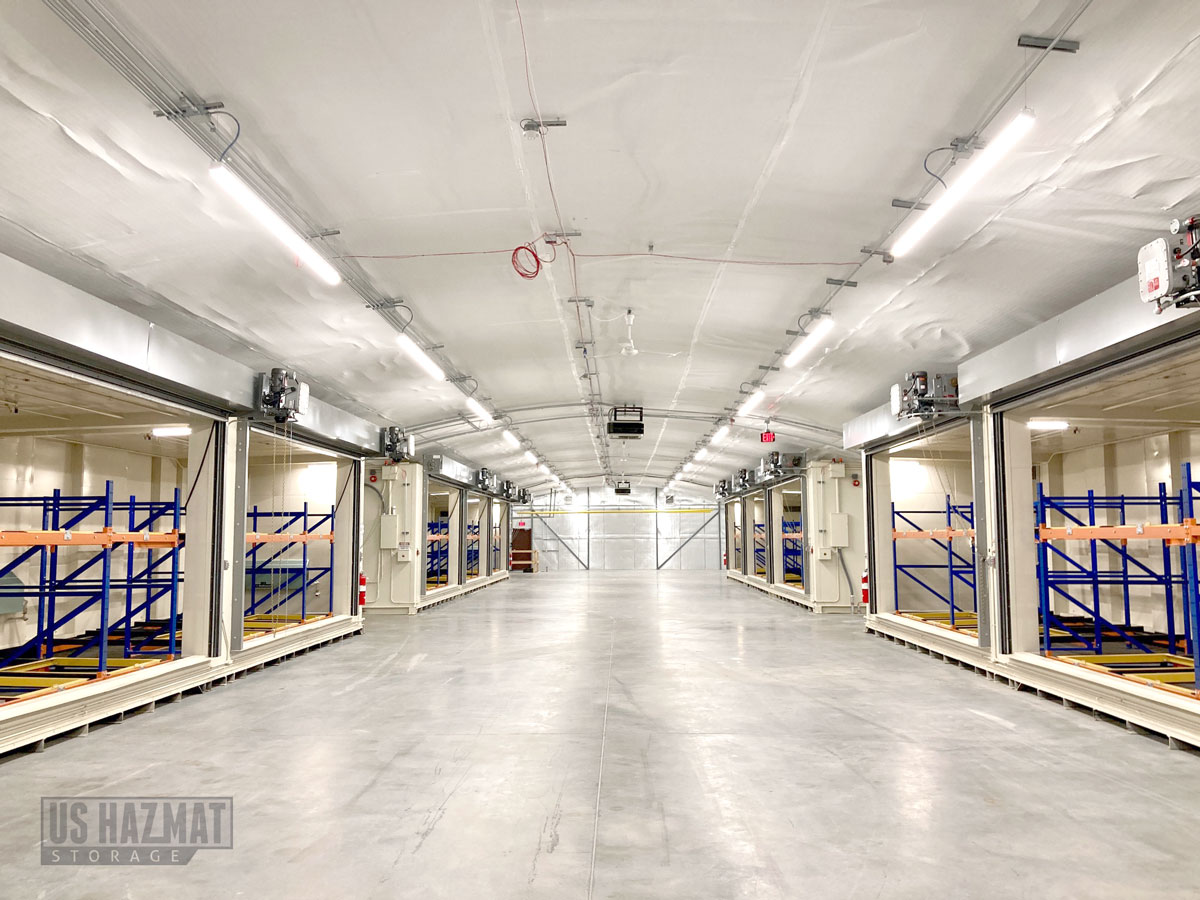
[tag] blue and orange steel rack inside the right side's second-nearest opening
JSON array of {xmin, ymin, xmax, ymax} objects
[{"xmin": 892, "ymin": 494, "xmax": 979, "ymax": 630}]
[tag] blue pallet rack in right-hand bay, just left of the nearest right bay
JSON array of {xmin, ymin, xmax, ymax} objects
[{"xmin": 892, "ymin": 494, "xmax": 978, "ymax": 628}]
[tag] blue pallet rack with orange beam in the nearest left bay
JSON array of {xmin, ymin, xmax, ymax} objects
[{"xmin": 0, "ymin": 481, "xmax": 184, "ymax": 672}]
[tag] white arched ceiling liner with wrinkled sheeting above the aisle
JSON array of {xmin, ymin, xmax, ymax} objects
[{"xmin": 0, "ymin": 0, "xmax": 1200, "ymax": 494}]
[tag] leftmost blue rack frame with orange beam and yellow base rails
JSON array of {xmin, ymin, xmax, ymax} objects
[{"xmin": 0, "ymin": 481, "xmax": 184, "ymax": 701}]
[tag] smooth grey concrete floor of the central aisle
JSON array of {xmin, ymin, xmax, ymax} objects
[{"xmin": 0, "ymin": 572, "xmax": 1200, "ymax": 900}]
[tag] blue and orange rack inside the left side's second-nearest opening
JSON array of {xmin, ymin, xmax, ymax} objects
[{"xmin": 242, "ymin": 502, "xmax": 337, "ymax": 630}]
